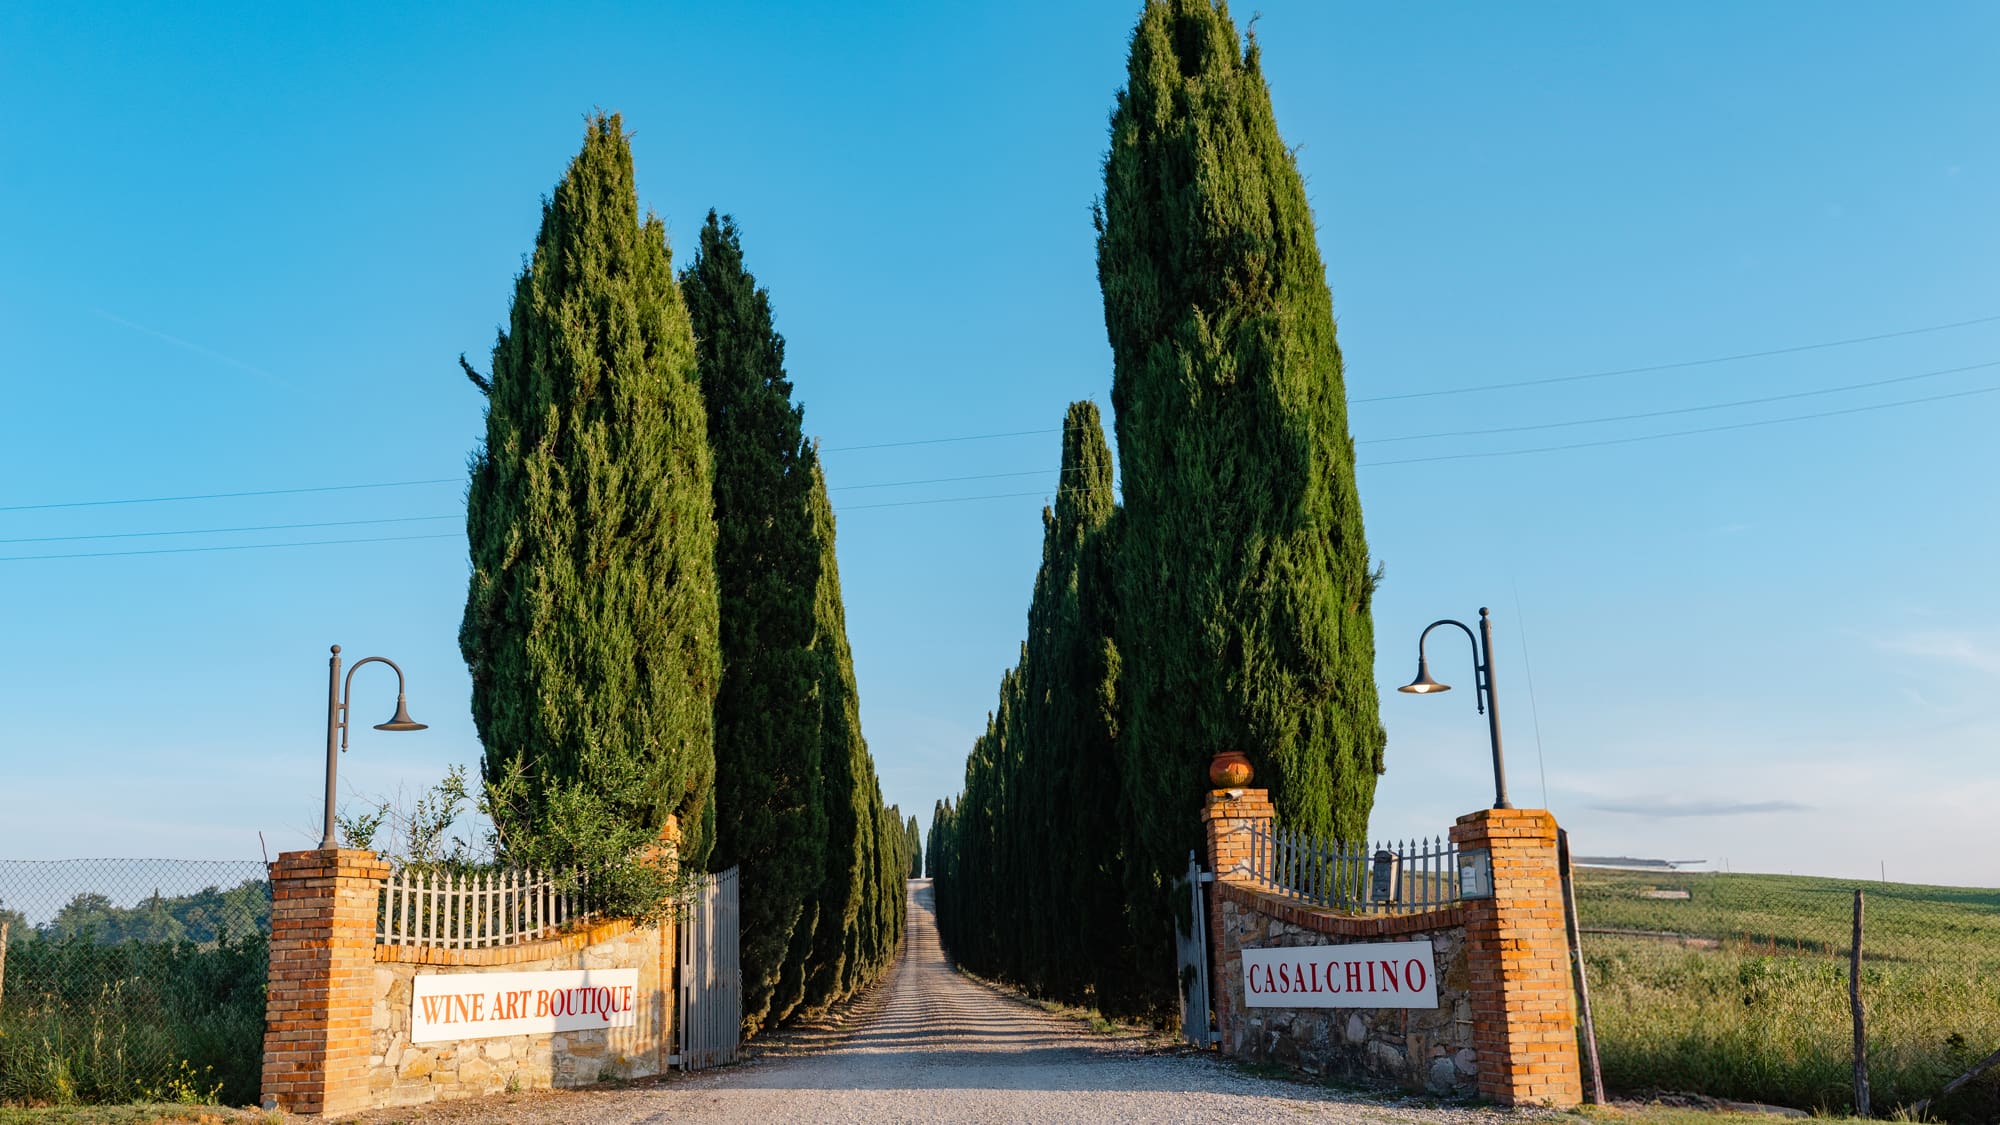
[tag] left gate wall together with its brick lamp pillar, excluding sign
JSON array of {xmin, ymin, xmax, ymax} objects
[{"xmin": 264, "ymin": 849, "xmax": 676, "ymax": 1117}]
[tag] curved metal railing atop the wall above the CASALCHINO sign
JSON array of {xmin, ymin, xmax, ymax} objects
[{"xmin": 1250, "ymin": 823, "xmax": 1460, "ymax": 915}]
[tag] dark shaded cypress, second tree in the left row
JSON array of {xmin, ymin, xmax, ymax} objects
[{"xmin": 680, "ymin": 210, "xmax": 826, "ymax": 1035}]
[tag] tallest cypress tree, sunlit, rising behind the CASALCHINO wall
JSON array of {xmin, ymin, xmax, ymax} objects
[{"xmin": 1098, "ymin": 0, "xmax": 1384, "ymax": 1008}]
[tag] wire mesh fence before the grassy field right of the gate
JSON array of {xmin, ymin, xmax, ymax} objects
[{"xmin": 1576, "ymin": 867, "xmax": 2000, "ymax": 1121}]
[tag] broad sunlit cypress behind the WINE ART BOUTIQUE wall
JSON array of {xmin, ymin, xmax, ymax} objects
[{"xmin": 458, "ymin": 116, "xmax": 720, "ymax": 865}]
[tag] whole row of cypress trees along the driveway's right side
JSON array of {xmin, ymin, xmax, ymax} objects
[{"xmin": 930, "ymin": 0, "xmax": 1384, "ymax": 1015}]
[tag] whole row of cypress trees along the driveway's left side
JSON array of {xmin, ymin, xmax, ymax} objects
[{"xmin": 460, "ymin": 114, "xmax": 910, "ymax": 1033}]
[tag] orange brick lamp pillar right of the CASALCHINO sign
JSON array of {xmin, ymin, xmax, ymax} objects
[{"xmin": 1452, "ymin": 809, "xmax": 1584, "ymax": 1109}]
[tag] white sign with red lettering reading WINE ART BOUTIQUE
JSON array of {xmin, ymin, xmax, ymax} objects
[{"xmin": 410, "ymin": 969, "xmax": 638, "ymax": 1043}]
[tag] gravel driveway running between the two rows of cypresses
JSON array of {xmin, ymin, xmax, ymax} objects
[{"xmin": 348, "ymin": 881, "xmax": 1554, "ymax": 1125}]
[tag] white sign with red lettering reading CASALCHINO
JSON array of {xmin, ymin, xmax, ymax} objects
[{"xmin": 1244, "ymin": 941, "xmax": 1438, "ymax": 1007}]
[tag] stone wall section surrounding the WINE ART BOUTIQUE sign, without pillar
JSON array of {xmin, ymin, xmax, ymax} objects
[{"xmin": 368, "ymin": 921, "xmax": 674, "ymax": 1107}]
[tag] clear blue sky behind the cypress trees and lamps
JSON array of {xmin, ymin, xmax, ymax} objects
[{"xmin": 0, "ymin": 0, "xmax": 2000, "ymax": 885}]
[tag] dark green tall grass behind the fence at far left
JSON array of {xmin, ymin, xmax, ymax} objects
[{"xmin": 0, "ymin": 933, "xmax": 270, "ymax": 1105}]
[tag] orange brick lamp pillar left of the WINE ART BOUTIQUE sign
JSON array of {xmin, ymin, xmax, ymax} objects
[{"xmin": 264, "ymin": 849, "xmax": 388, "ymax": 1113}]
